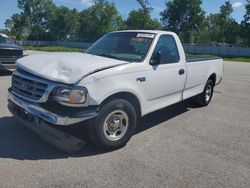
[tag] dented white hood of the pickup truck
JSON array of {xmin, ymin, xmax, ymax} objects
[{"xmin": 16, "ymin": 52, "xmax": 128, "ymax": 84}]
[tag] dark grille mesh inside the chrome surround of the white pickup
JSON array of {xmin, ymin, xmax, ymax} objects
[{"xmin": 12, "ymin": 74, "xmax": 48, "ymax": 101}]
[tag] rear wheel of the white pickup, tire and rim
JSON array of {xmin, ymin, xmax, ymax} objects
[{"xmin": 196, "ymin": 80, "xmax": 214, "ymax": 107}]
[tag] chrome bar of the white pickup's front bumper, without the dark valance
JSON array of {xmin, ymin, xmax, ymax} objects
[{"xmin": 8, "ymin": 90, "xmax": 97, "ymax": 126}]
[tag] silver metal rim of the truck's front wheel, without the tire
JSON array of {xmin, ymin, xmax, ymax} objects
[{"xmin": 103, "ymin": 110, "xmax": 129, "ymax": 141}]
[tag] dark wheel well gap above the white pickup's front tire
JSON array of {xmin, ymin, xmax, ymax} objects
[{"xmin": 101, "ymin": 92, "xmax": 141, "ymax": 117}]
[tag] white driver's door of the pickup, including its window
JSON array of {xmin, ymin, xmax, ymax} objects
[{"xmin": 147, "ymin": 35, "xmax": 186, "ymax": 106}]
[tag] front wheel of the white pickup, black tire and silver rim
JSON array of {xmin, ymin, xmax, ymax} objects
[{"xmin": 88, "ymin": 99, "xmax": 137, "ymax": 150}]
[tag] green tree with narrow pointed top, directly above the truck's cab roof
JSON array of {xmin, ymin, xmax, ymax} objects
[{"xmin": 126, "ymin": 0, "xmax": 162, "ymax": 29}]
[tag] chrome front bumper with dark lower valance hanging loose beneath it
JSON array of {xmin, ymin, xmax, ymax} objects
[{"xmin": 8, "ymin": 91, "xmax": 97, "ymax": 154}]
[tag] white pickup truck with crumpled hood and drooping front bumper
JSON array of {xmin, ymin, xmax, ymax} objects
[{"xmin": 8, "ymin": 30, "xmax": 223, "ymax": 150}]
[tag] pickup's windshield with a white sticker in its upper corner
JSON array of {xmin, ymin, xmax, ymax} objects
[{"xmin": 86, "ymin": 32, "xmax": 155, "ymax": 62}]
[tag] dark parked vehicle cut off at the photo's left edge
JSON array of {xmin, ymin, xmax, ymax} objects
[{"xmin": 0, "ymin": 33, "xmax": 23, "ymax": 69}]
